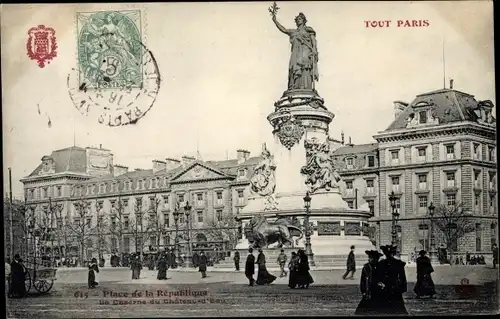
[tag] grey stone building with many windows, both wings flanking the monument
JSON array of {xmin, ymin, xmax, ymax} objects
[{"xmin": 22, "ymin": 89, "xmax": 498, "ymax": 255}]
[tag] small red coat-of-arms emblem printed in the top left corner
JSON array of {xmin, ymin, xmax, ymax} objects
[{"xmin": 26, "ymin": 24, "xmax": 57, "ymax": 68}]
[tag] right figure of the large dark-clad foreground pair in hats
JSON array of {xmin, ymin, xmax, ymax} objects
[{"xmin": 378, "ymin": 245, "xmax": 408, "ymax": 315}]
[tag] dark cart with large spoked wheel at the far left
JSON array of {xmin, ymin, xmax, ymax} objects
[{"xmin": 24, "ymin": 259, "xmax": 57, "ymax": 293}]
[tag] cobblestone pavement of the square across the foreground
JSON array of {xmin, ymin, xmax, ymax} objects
[{"xmin": 7, "ymin": 269, "xmax": 498, "ymax": 318}]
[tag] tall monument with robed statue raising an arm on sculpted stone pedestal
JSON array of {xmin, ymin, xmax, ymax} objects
[{"xmin": 232, "ymin": 2, "xmax": 374, "ymax": 266}]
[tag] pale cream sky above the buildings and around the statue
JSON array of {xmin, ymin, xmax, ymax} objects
[{"xmin": 1, "ymin": 1, "xmax": 496, "ymax": 197}]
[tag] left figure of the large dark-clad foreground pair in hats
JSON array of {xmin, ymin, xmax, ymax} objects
[{"xmin": 354, "ymin": 250, "xmax": 382, "ymax": 315}]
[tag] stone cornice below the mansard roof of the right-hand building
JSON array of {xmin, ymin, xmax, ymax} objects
[{"xmin": 373, "ymin": 122, "xmax": 496, "ymax": 143}]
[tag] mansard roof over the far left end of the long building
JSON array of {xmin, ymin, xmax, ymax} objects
[{"xmin": 28, "ymin": 146, "xmax": 87, "ymax": 177}]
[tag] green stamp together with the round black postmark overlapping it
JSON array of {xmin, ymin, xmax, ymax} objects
[{"xmin": 67, "ymin": 10, "xmax": 161, "ymax": 126}]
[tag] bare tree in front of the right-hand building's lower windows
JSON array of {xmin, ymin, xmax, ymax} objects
[{"xmin": 431, "ymin": 203, "xmax": 475, "ymax": 264}]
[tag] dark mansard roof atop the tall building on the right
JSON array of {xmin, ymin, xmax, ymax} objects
[{"xmin": 385, "ymin": 89, "xmax": 488, "ymax": 131}]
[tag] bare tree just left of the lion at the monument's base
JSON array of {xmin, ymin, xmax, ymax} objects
[{"xmin": 203, "ymin": 215, "xmax": 239, "ymax": 249}]
